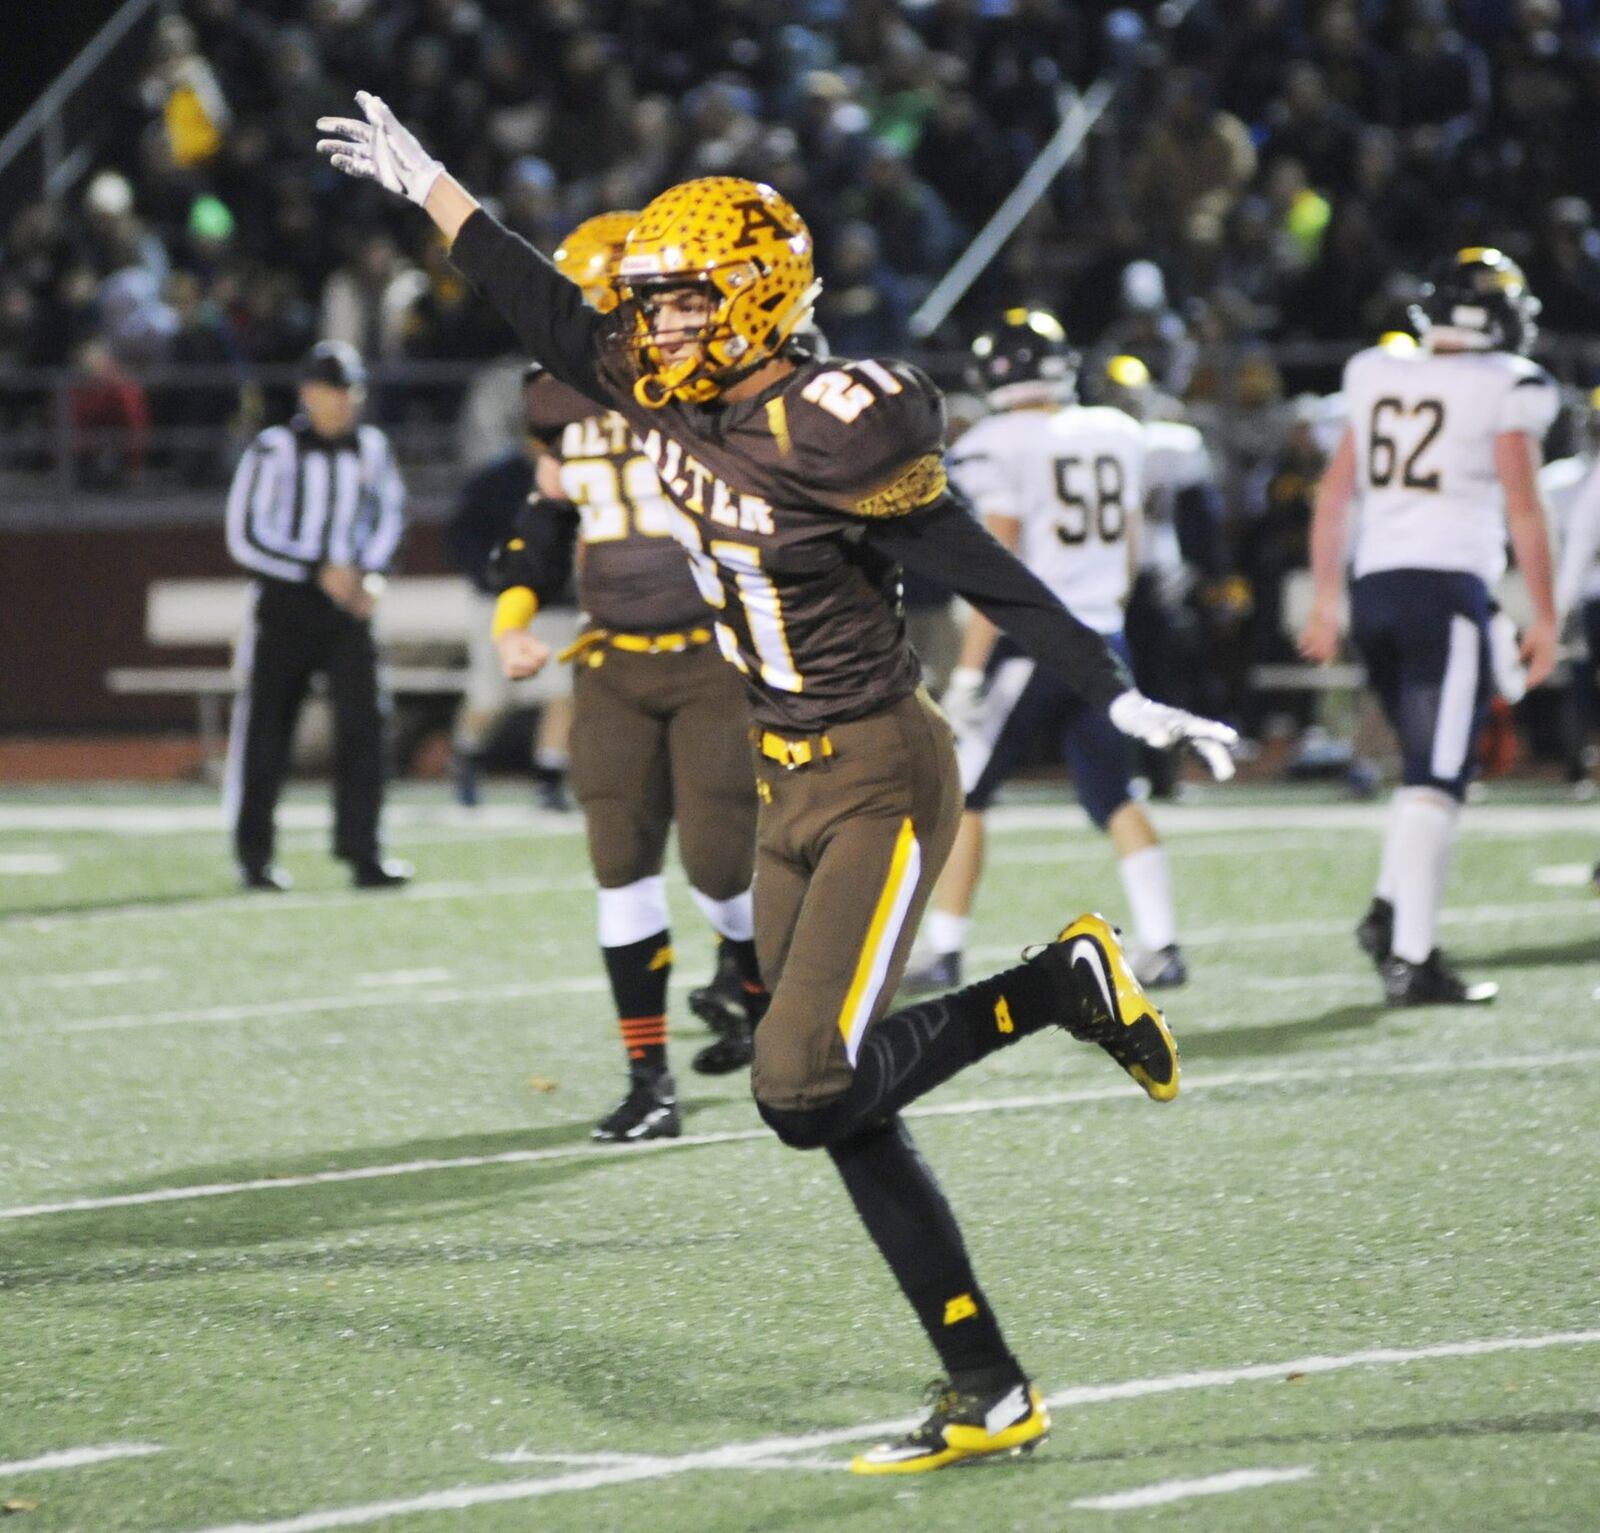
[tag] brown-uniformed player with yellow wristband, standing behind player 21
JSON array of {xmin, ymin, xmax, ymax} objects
[{"xmin": 494, "ymin": 213, "xmax": 766, "ymax": 1144}]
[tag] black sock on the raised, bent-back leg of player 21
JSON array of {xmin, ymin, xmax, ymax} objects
[{"xmin": 842, "ymin": 963, "xmax": 1069, "ymax": 1123}]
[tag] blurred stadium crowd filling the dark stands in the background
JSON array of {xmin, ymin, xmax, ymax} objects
[{"xmin": 0, "ymin": 0, "xmax": 1600, "ymax": 761}]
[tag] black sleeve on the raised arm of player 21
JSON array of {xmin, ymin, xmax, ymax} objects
[{"xmin": 450, "ymin": 208, "xmax": 613, "ymax": 410}]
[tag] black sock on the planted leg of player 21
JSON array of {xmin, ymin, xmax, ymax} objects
[{"xmin": 829, "ymin": 1119, "xmax": 1022, "ymax": 1392}]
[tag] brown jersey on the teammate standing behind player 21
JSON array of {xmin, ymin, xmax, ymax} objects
[{"xmin": 528, "ymin": 373, "xmax": 707, "ymax": 634}]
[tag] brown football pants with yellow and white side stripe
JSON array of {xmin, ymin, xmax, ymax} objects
[{"xmin": 752, "ymin": 691, "xmax": 962, "ymax": 1111}]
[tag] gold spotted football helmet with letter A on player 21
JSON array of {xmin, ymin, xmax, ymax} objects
[{"xmin": 618, "ymin": 176, "xmax": 822, "ymax": 408}]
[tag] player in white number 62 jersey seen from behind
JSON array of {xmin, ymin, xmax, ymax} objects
[{"xmin": 1301, "ymin": 246, "xmax": 1558, "ymax": 1007}]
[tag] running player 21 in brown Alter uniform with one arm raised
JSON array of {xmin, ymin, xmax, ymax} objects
[{"xmin": 318, "ymin": 93, "xmax": 1232, "ymax": 1474}]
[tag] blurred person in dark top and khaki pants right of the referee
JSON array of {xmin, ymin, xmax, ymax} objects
[{"xmin": 445, "ymin": 368, "xmax": 578, "ymax": 811}]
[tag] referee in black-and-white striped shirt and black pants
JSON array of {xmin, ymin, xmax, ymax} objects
[{"xmin": 224, "ymin": 341, "xmax": 411, "ymax": 890}]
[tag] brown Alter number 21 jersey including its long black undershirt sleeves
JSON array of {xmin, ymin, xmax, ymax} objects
[{"xmin": 451, "ymin": 210, "xmax": 1130, "ymax": 730}]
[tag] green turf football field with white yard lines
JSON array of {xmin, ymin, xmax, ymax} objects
[{"xmin": 0, "ymin": 786, "xmax": 1600, "ymax": 1533}]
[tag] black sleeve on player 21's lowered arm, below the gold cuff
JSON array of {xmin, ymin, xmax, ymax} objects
[{"xmin": 867, "ymin": 494, "xmax": 1133, "ymax": 707}]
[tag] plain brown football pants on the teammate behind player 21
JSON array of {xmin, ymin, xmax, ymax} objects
[{"xmin": 571, "ymin": 643, "xmax": 755, "ymax": 899}]
